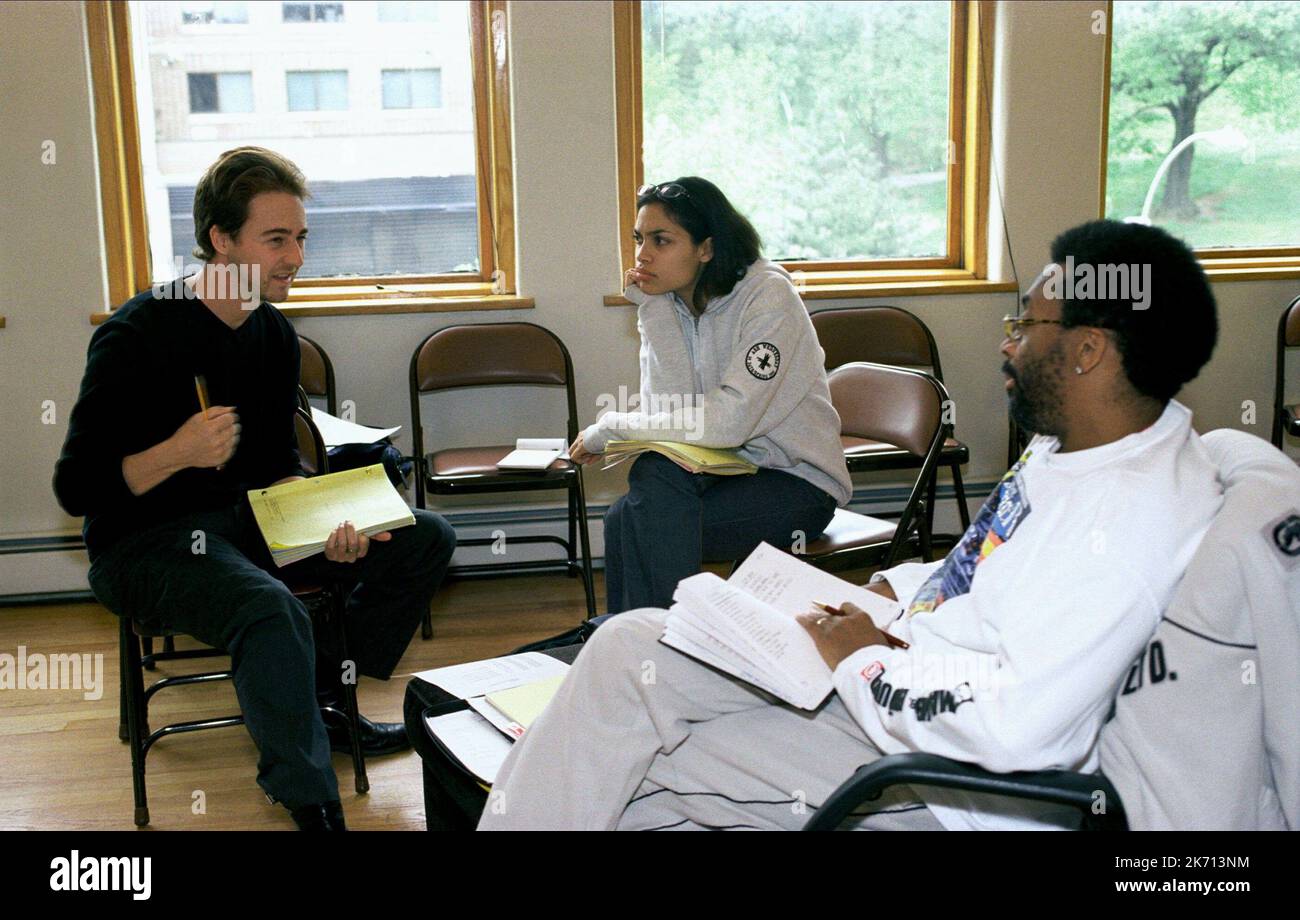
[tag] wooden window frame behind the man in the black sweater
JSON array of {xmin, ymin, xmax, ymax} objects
[{"xmin": 85, "ymin": 0, "xmax": 534, "ymax": 322}]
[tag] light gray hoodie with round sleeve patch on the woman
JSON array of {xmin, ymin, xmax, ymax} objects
[{"xmin": 582, "ymin": 259, "xmax": 853, "ymax": 507}]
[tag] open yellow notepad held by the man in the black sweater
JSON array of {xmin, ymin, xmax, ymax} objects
[{"xmin": 241, "ymin": 464, "xmax": 415, "ymax": 567}]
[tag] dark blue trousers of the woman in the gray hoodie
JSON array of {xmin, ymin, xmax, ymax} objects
[{"xmin": 605, "ymin": 454, "xmax": 836, "ymax": 613}]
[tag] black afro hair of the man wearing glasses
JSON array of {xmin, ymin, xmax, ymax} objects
[{"xmin": 1052, "ymin": 221, "xmax": 1218, "ymax": 402}]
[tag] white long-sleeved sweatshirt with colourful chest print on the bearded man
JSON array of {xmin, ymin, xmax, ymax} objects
[{"xmin": 835, "ymin": 400, "xmax": 1222, "ymax": 829}]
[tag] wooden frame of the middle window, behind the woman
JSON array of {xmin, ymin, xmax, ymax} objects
[{"xmin": 605, "ymin": 0, "xmax": 1015, "ymax": 305}]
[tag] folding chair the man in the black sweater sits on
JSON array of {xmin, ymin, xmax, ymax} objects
[{"xmin": 117, "ymin": 409, "xmax": 371, "ymax": 826}]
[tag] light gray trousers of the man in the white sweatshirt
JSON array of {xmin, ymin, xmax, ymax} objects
[{"xmin": 478, "ymin": 609, "xmax": 941, "ymax": 830}]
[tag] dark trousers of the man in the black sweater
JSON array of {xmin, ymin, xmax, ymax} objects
[{"xmin": 90, "ymin": 505, "xmax": 456, "ymax": 808}]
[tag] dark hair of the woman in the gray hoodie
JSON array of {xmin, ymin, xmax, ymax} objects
[{"xmin": 637, "ymin": 175, "xmax": 763, "ymax": 300}]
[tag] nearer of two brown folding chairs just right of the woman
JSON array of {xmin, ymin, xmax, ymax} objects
[{"xmin": 800, "ymin": 361, "xmax": 948, "ymax": 572}]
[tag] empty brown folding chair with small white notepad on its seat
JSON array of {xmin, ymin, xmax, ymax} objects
[{"xmin": 411, "ymin": 322, "xmax": 595, "ymax": 639}]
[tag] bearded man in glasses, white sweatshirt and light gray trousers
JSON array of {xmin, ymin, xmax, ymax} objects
[{"xmin": 480, "ymin": 221, "xmax": 1222, "ymax": 829}]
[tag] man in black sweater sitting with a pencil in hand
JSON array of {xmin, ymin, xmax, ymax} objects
[{"xmin": 55, "ymin": 147, "xmax": 455, "ymax": 829}]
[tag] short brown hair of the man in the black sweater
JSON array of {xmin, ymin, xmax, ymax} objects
[{"xmin": 191, "ymin": 147, "xmax": 311, "ymax": 260}]
